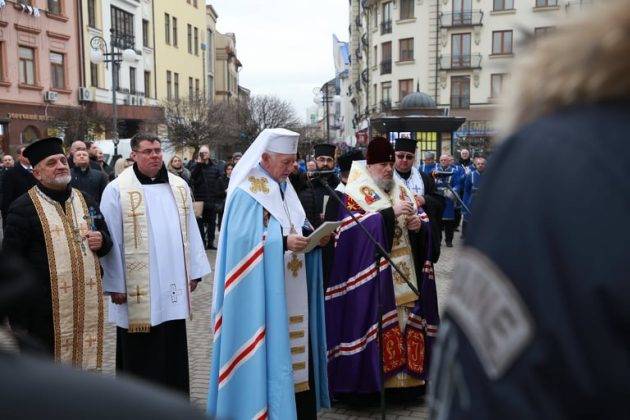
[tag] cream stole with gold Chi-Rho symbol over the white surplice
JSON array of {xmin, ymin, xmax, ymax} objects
[{"xmin": 119, "ymin": 167, "xmax": 192, "ymax": 333}]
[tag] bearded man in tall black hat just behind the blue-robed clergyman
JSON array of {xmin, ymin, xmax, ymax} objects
[{"xmin": 298, "ymin": 144, "xmax": 339, "ymax": 229}]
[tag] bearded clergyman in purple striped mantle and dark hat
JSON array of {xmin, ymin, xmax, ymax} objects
[{"xmin": 325, "ymin": 137, "xmax": 439, "ymax": 399}]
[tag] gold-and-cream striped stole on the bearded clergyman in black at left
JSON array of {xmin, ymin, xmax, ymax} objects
[{"xmin": 28, "ymin": 187, "xmax": 103, "ymax": 370}]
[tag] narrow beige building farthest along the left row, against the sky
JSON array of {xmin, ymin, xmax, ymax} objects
[{"xmin": 214, "ymin": 32, "xmax": 243, "ymax": 102}]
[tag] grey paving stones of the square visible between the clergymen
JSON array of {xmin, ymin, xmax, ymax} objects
[{"xmin": 0, "ymin": 231, "xmax": 459, "ymax": 420}]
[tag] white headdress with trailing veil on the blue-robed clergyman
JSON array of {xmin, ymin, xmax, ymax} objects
[{"xmin": 225, "ymin": 128, "xmax": 300, "ymax": 201}]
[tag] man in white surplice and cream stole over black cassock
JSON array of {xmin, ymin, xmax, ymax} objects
[{"xmin": 101, "ymin": 133, "xmax": 210, "ymax": 395}]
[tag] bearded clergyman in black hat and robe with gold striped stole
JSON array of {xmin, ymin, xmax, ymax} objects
[{"xmin": 3, "ymin": 137, "xmax": 112, "ymax": 370}]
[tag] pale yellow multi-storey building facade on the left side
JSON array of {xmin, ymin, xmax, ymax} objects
[{"xmin": 154, "ymin": 0, "xmax": 207, "ymax": 101}]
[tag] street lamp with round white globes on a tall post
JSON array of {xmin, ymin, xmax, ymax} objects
[{"xmin": 90, "ymin": 29, "xmax": 137, "ymax": 159}]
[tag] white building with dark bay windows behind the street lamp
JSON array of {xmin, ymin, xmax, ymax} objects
[{"xmin": 79, "ymin": 0, "xmax": 163, "ymax": 138}]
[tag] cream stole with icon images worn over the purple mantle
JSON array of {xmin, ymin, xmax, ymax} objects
[{"xmin": 346, "ymin": 162, "xmax": 418, "ymax": 306}]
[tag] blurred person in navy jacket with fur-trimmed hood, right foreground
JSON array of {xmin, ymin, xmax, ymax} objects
[{"xmin": 430, "ymin": 1, "xmax": 630, "ymax": 419}]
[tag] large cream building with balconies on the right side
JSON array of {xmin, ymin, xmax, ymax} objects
[{"xmin": 348, "ymin": 0, "xmax": 590, "ymax": 152}]
